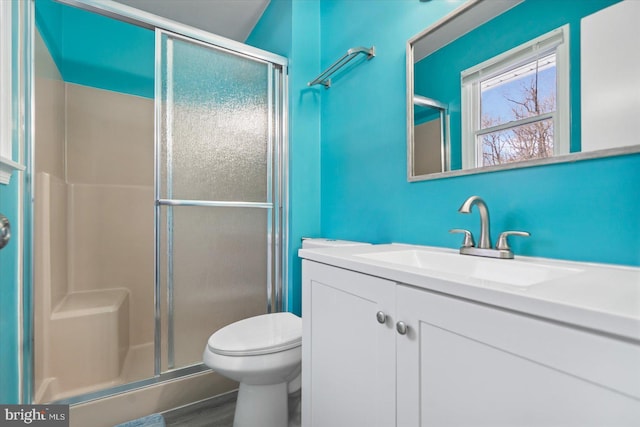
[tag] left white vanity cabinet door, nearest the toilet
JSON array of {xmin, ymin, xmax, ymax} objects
[{"xmin": 302, "ymin": 260, "xmax": 396, "ymax": 427}]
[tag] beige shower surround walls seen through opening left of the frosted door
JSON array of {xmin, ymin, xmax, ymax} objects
[{"xmin": 34, "ymin": 24, "xmax": 154, "ymax": 352}]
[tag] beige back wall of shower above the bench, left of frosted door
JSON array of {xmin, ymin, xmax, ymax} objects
[{"xmin": 66, "ymin": 83, "xmax": 154, "ymax": 345}]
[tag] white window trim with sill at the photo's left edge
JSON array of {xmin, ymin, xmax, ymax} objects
[{"xmin": 0, "ymin": 0, "xmax": 24, "ymax": 184}]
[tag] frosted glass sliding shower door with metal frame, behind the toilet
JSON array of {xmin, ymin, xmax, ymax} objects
[{"xmin": 155, "ymin": 30, "xmax": 284, "ymax": 373}]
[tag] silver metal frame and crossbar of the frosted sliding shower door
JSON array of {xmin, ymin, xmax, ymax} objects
[{"xmin": 154, "ymin": 28, "xmax": 286, "ymax": 375}]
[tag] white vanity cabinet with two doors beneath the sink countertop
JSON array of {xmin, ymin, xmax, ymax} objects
[{"xmin": 302, "ymin": 260, "xmax": 640, "ymax": 427}]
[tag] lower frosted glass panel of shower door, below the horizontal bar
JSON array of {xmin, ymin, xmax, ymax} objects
[{"xmin": 161, "ymin": 207, "xmax": 269, "ymax": 368}]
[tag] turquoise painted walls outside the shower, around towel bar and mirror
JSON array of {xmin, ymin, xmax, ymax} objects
[{"xmin": 0, "ymin": 0, "xmax": 640, "ymax": 423}]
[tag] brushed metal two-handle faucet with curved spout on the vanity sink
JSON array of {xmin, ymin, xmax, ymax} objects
[{"xmin": 449, "ymin": 196, "xmax": 531, "ymax": 259}]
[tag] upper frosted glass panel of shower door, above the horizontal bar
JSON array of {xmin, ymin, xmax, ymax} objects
[{"xmin": 161, "ymin": 34, "xmax": 270, "ymax": 202}]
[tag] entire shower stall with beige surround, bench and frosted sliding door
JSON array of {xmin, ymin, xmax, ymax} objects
[{"xmin": 25, "ymin": 0, "xmax": 287, "ymax": 410}]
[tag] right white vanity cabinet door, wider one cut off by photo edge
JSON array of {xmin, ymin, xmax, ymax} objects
[{"xmin": 396, "ymin": 286, "xmax": 640, "ymax": 427}]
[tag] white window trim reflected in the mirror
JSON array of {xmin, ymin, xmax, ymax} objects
[{"xmin": 461, "ymin": 25, "xmax": 571, "ymax": 169}]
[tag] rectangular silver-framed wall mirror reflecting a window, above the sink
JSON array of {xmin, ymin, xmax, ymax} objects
[{"xmin": 407, "ymin": 0, "xmax": 640, "ymax": 181}]
